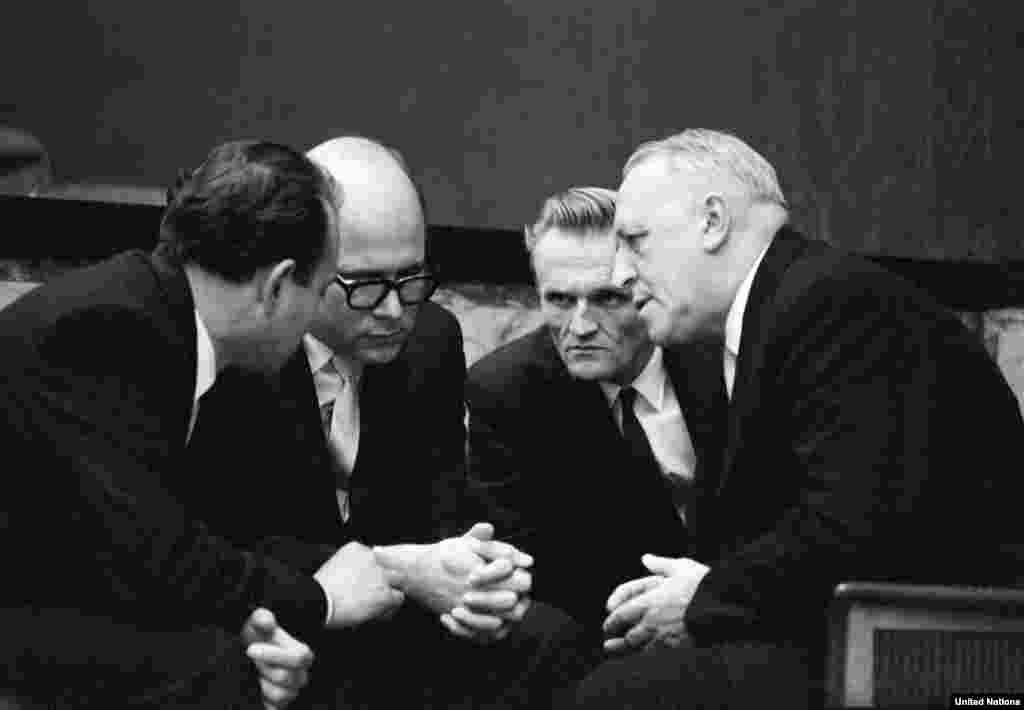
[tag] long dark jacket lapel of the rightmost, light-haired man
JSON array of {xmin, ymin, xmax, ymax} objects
[{"xmin": 718, "ymin": 226, "xmax": 807, "ymax": 493}]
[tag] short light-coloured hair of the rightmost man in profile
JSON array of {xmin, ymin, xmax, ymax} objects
[{"xmin": 623, "ymin": 128, "xmax": 786, "ymax": 208}]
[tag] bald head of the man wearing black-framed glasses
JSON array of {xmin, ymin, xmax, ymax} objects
[{"xmin": 308, "ymin": 136, "xmax": 426, "ymax": 363}]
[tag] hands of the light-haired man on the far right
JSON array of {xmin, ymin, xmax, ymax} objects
[{"xmin": 604, "ymin": 554, "xmax": 710, "ymax": 652}]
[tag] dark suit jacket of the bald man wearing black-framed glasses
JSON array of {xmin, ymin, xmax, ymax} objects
[{"xmin": 182, "ymin": 302, "xmax": 466, "ymax": 572}]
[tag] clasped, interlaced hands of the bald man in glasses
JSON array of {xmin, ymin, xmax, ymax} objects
[{"xmin": 374, "ymin": 523, "xmax": 534, "ymax": 641}]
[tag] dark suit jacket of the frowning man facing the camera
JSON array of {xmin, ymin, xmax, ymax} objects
[{"xmin": 466, "ymin": 327, "xmax": 725, "ymax": 630}]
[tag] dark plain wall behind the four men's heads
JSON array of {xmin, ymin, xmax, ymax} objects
[{"xmin": 0, "ymin": 0, "xmax": 1007, "ymax": 259}]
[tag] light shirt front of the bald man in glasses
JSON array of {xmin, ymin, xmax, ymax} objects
[{"xmin": 303, "ymin": 334, "xmax": 362, "ymax": 520}]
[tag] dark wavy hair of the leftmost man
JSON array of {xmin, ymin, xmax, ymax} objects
[{"xmin": 160, "ymin": 140, "xmax": 341, "ymax": 285}]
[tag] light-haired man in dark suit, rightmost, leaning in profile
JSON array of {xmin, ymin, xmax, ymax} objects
[{"xmin": 579, "ymin": 130, "xmax": 1024, "ymax": 708}]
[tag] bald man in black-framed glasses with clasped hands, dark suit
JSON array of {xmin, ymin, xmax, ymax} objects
[{"xmin": 178, "ymin": 137, "xmax": 589, "ymax": 707}]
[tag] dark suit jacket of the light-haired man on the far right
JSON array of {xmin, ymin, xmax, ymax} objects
[{"xmin": 686, "ymin": 228, "xmax": 1024, "ymax": 645}]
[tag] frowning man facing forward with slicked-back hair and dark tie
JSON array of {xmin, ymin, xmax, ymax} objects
[{"xmin": 466, "ymin": 187, "xmax": 721, "ymax": 635}]
